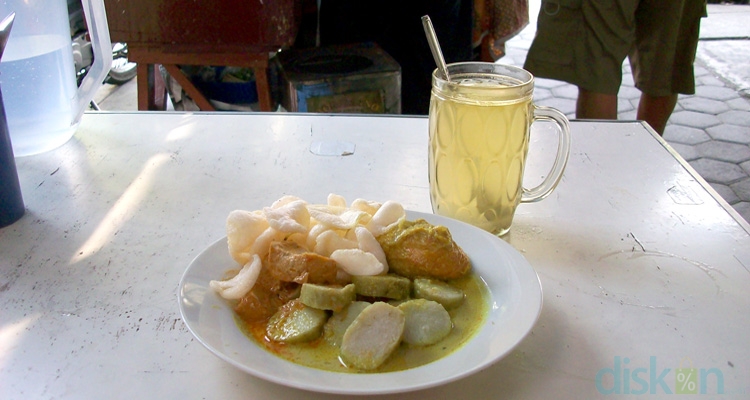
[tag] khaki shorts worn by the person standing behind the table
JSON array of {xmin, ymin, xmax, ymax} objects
[{"xmin": 524, "ymin": 0, "xmax": 706, "ymax": 96}]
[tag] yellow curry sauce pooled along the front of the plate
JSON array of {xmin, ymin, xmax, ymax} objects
[{"xmin": 235, "ymin": 271, "xmax": 490, "ymax": 373}]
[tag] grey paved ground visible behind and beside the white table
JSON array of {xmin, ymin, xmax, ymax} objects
[{"xmin": 96, "ymin": 0, "xmax": 750, "ymax": 221}]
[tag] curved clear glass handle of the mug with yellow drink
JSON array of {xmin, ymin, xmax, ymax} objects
[{"xmin": 521, "ymin": 105, "xmax": 570, "ymax": 203}]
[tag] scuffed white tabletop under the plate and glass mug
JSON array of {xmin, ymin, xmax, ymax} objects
[{"xmin": 0, "ymin": 112, "xmax": 750, "ymax": 399}]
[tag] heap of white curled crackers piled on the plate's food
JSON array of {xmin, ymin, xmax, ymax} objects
[{"xmin": 211, "ymin": 193, "xmax": 396, "ymax": 299}]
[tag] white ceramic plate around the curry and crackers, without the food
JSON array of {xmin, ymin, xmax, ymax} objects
[{"xmin": 178, "ymin": 211, "xmax": 542, "ymax": 394}]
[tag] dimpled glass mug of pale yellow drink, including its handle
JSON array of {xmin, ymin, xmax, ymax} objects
[{"xmin": 428, "ymin": 62, "xmax": 570, "ymax": 236}]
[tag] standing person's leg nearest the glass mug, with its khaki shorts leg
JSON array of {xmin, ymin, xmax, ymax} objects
[{"xmin": 524, "ymin": 0, "xmax": 638, "ymax": 119}]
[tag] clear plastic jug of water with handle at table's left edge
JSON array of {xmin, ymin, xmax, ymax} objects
[{"xmin": 0, "ymin": 0, "xmax": 112, "ymax": 157}]
